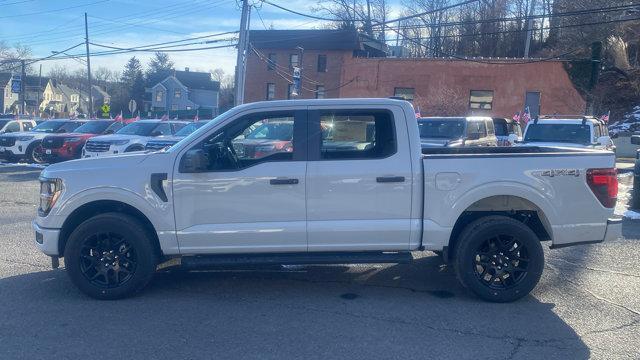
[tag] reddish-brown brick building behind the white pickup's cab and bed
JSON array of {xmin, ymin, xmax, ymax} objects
[{"xmin": 245, "ymin": 30, "xmax": 585, "ymax": 116}]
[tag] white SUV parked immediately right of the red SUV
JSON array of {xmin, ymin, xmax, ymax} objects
[{"xmin": 82, "ymin": 119, "xmax": 189, "ymax": 158}]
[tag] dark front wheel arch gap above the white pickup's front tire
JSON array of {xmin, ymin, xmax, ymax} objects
[{"xmin": 58, "ymin": 200, "xmax": 162, "ymax": 256}]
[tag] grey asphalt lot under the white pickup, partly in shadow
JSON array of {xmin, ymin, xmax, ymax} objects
[{"xmin": 0, "ymin": 166, "xmax": 640, "ymax": 360}]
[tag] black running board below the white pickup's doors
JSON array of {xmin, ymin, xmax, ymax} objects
[{"xmin": 181, "ymin": 252, "xmax": 413, "ymax": 269}]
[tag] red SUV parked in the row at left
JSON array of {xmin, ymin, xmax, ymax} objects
[{"xmin": 38, "ymin": 120, "xmax": 123, "ymax": 163}]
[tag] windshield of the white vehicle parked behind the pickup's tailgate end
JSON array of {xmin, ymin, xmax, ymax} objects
[{"xmin": 524, "ymin": 124, "xmax": 591, "ymax": 144}]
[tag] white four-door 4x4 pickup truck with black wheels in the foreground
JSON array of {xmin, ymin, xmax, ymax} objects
[{"xmin": 33, "ymin": 99, "xmax": 621, "ymax": 302}]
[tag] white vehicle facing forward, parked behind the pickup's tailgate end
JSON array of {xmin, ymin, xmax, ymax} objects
[{"xmin": 521, "ymin": 116, "xmax": 615, "ymax": 150}]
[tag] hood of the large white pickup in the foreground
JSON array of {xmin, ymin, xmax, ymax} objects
[{"xmin": 41, "ymin": 152, "xmax": 148, "ymax": 179}]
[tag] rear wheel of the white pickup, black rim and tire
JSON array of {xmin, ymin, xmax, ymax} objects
[{"xmin": 454, "ymin": 216, "xmax": 544, "ymax": 302}]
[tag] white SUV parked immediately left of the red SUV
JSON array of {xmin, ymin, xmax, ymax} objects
[{"xmin": 0, "ymin": 119, "xmax": 87, "ymax": 163}]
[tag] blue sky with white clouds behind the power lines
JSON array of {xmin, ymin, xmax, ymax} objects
[{"xmin": 0, "ymin": 0, "xmax": 400, "ymax": 74}]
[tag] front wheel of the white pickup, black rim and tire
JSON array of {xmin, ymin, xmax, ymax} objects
[{"xmin": 64, "ymin": 213, "xmax": 157, "ymax": 300}]
